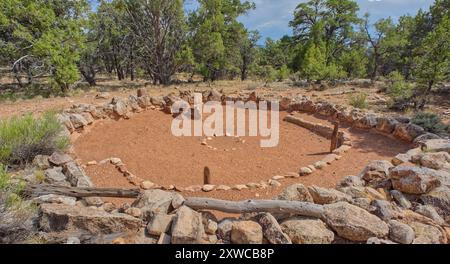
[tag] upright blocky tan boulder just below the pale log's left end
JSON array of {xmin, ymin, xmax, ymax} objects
[{"xmin": 171, "ymin": 206, "xmax": 205, "ymax": 244}]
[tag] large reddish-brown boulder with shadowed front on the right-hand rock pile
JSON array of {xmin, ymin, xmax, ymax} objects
[{"xmin": 389, "ymin": 165, "xmax": 441, "ymax": 194}]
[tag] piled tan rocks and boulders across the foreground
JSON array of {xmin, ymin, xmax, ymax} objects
[{"xmin": 2, "ymin": 139, "xmax": 450, "ymax": 244}]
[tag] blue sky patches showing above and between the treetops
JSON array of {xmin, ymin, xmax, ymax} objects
[{"xmin": 186, "ymin": 0, "xmax": 434, "ymax": 44}]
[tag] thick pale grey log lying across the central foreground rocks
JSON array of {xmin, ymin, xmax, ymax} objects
[{"xmin": 184, "ymin": 197, "xmax": 323, "ymax": 218}]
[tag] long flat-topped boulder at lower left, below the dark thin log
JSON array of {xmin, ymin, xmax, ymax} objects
[{"xmin": 39, "ymin": 203, "xmax": 142, "ymax": 234}]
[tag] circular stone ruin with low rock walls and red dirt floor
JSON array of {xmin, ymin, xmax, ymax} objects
[{"xmin": 60, "ymin": 90, "xmax": 422, "ymax": 199}]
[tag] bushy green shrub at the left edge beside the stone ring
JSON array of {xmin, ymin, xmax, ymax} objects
[{"xmin": 0, "ymin": 112, "xmax": 69, "ymax": 165}]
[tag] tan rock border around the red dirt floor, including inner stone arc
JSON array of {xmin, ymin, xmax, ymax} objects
[{"xmin": 58, "ymin": 89, "xmax": 446, "ymax": 192}]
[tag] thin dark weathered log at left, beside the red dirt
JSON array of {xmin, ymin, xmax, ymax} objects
[{"xmin": 24, "ymin": 184, "xmax": 140, "ymax": 198}]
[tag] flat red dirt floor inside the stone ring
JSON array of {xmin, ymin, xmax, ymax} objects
[{"xmin": 74, "ymin": 108, "xmax": 411, "ymax": 203}]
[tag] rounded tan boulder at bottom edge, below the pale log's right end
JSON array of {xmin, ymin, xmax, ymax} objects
[{"xmin": 281, "ymin": 217, "xmax": 334, "ymax": 244}]
